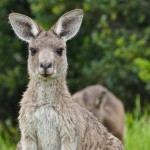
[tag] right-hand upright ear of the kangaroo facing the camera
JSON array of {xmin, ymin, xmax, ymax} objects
[{"xmin": 53, "ymin": 9, "xmax": 83, "ymax": 41}]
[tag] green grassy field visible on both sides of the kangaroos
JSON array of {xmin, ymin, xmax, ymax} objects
[{"xmin": 0, "ymin": 101, "xmax": 150, "ymax": 150}]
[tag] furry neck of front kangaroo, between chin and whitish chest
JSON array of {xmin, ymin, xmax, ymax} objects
[{"xmin": 24, "ymin": 78, "xmax": 70, "ymax": 106}]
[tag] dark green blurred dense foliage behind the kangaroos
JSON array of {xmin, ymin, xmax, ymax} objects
[{"xmin": 0, "ymin": 0, "xmax": 150, "ymax": 122}]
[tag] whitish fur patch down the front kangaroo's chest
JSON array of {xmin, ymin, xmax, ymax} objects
[{"xmin": 34, "ymin": 106, "xmax": 61, "ymax": 150}]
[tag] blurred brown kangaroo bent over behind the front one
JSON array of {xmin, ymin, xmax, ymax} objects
[{"xmin": 72, "ymin": 85, "xmax": 125, "ymax": 142}]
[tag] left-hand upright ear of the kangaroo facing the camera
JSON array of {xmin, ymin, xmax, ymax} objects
[{"xmin": 9, "ymin": 13, "xmax": 40, "ymax": 42}]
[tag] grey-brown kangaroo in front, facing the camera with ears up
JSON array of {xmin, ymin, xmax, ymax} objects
[{"xmin": 9, "ymin": 9, "xmax": 123, "ymax": 150}]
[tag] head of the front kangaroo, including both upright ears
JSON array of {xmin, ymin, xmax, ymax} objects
[{"xmin": 9, "ymin": 9, "xmax": 83, "ymax": 79}]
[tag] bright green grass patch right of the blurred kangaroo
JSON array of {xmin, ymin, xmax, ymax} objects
[{"xmin": 125, "ymin": 97, "xmax": 150, "ymax": 150}]
